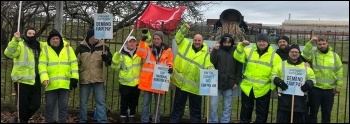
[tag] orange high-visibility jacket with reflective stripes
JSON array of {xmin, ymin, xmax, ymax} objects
[{"xmin": 136, "ymin": 41, "xmax": 173, "ymax": 94}]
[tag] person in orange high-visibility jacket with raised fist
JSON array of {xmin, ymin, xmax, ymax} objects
[{"xmin": 136, "ymin": 31, "xmax": 173, "ymax": 123}]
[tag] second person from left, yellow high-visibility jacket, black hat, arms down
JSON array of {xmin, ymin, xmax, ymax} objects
[{"xmin": 39, "ymin": 29, "xmax": 79, "ymax": 123}]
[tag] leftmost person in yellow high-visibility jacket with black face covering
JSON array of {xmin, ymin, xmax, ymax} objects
[{"xmin": 4, "ymin": 28, "xmax": 41, "ymax": 123}]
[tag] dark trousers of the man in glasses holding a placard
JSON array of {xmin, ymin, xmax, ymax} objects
[{"xmin": 276, "ymin": 111, "xmax": 305, "ymax": 123}]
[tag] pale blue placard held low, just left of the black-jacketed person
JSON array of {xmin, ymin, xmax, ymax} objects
[{"xmin": 199, "ymin": 69, "xmax": 218, "ymax": 96}]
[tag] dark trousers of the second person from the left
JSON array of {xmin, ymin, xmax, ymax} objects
[{"xmin": 45, "ymin": 89, "xmax": 69, "ymax": 123}]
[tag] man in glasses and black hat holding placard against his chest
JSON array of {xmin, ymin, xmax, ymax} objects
[{"xmin": 271, "ymin": 44, "xmax": 316, "ymax": 123}]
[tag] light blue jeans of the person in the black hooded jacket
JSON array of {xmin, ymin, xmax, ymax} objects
[{"xmin": 209, "ymin": 89, "xmax": 233, "ymax": 123}]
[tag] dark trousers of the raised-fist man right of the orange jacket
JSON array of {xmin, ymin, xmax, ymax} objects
[{"xmin": 170, "ymin": 87, "xmax": 202, "ymax": 123}]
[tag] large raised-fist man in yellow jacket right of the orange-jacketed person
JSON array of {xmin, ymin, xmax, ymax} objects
[{"xmin": 170, "ymin": 23, "xmax": 214, "ymax": 123}]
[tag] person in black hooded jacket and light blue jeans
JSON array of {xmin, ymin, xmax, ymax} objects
[{"xmin": 209, "ymin": 34, "xmax": 243, "ymax": 123}]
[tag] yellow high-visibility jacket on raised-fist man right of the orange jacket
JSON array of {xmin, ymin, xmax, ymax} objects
[{"xmin": 171, "ymin": 25, "xmax": 214, "ymax": 95}]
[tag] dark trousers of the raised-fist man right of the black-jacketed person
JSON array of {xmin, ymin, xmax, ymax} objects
[{"xmin": 240, "ymin": 88, "xmax": 271, "ymax": 123}]
